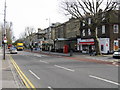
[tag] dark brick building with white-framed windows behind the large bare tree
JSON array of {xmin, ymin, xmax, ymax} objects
[{"xmin": 77, "ymin": 11, "xmax": 120, "ymax": 53}]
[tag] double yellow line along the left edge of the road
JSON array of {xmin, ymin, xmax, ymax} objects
[{"xmin": 9, "ymin": 55, "xmax": 36, "ymax": 90}]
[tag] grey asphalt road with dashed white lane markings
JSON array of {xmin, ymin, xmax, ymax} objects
[{"xmin": 11, "ymin": 51, "xmax": 120, "ymax": 90}]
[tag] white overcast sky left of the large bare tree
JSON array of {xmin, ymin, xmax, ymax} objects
[{"xmin": 0, "ymin": 0, "xmax": 68, "ymax": 38}]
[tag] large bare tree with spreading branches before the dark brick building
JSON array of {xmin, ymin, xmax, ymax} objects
[{"xmin": 62, "ymin": 0, "xmax": 116, "ymax": 55}]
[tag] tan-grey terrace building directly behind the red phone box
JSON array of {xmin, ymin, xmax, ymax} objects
[{"xmin": 55, "ymin": 18, "xmax": 80, "ymax": 52}]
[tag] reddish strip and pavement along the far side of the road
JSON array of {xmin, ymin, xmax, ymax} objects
[{"xmin": 26, "ymin": 50, "xmax": 120, "ymax": 62}]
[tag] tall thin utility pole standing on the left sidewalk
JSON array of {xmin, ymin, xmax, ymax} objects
[{"xmin": 3, "ymin": 0, "xmax": 6, "ymax": 60}]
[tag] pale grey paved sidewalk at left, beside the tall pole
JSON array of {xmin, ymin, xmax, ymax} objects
[{"xmin": 0, "ymin": 49, "xmax": 20, "ymax": 89}]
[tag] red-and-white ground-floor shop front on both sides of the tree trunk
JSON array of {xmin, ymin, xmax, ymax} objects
[{"xmin": 77, "ymin": 38, "xmax": 109, "ymax": 53}]
